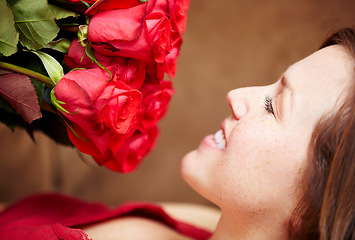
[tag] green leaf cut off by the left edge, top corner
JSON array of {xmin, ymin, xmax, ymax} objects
[{"xmin": 0, "ymin": 0, "xmax": 19, "ymax": 57}]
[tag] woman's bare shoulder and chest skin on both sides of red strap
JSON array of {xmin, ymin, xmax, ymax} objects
[{"xmin": 83, "ymin": 203, "xmax": 220, "ymax": 240}]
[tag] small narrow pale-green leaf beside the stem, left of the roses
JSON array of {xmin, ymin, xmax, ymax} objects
[{"xmin": 32, "ymin": 51, "xmax": 64, "ymax": 83}]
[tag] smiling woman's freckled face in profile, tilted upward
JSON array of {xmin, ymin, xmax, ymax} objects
[{"xmin": 181, "ymin": 46, "xmax": 353, "ymax": 220}]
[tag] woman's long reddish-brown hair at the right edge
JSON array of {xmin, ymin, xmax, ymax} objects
[{"xmin": 290, "ymin": 28, "xmax": 355, "ymax": 240}]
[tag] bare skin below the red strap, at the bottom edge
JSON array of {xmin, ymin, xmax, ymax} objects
[{"xmin": 83, "ymin": 216, "xmax": 190, "ymax": 240}]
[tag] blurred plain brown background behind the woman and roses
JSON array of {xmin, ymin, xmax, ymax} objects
[{"xmin": 0, "ymin": 0, "xmax": 355, "ymax": 205}]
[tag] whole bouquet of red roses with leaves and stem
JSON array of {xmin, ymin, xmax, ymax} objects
[{"xmin": 0, "ymin": 0, "xmax": 189, "ymax": 173}]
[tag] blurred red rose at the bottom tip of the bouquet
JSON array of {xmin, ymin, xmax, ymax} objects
[{"xmin": 102, "ymin": 127, "xmax": 158, "ymax": 173}]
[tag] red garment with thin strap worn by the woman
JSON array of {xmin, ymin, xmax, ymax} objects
[{"xmin": 0, "ymin": 194, "xmax": 211, "ymax": 240}]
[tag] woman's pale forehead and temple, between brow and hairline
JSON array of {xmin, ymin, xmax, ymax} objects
[{"xmin": 284, "ymin": 45, "xmax": 354, "ymax": 125}]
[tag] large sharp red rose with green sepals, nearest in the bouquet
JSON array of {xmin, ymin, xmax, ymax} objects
[{"xmin": 53, "ymin": 67, "xmax": 146, "ymax": 170}]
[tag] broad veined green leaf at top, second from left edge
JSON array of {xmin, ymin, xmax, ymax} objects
[{"xmin": 7, "ymin": 0, "xmax": 59, "ymax": 50}]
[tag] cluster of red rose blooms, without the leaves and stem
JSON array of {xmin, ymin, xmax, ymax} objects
[{"xmin": 52, "ymin": 0, "xmax": 190, "ymax": 173}]
